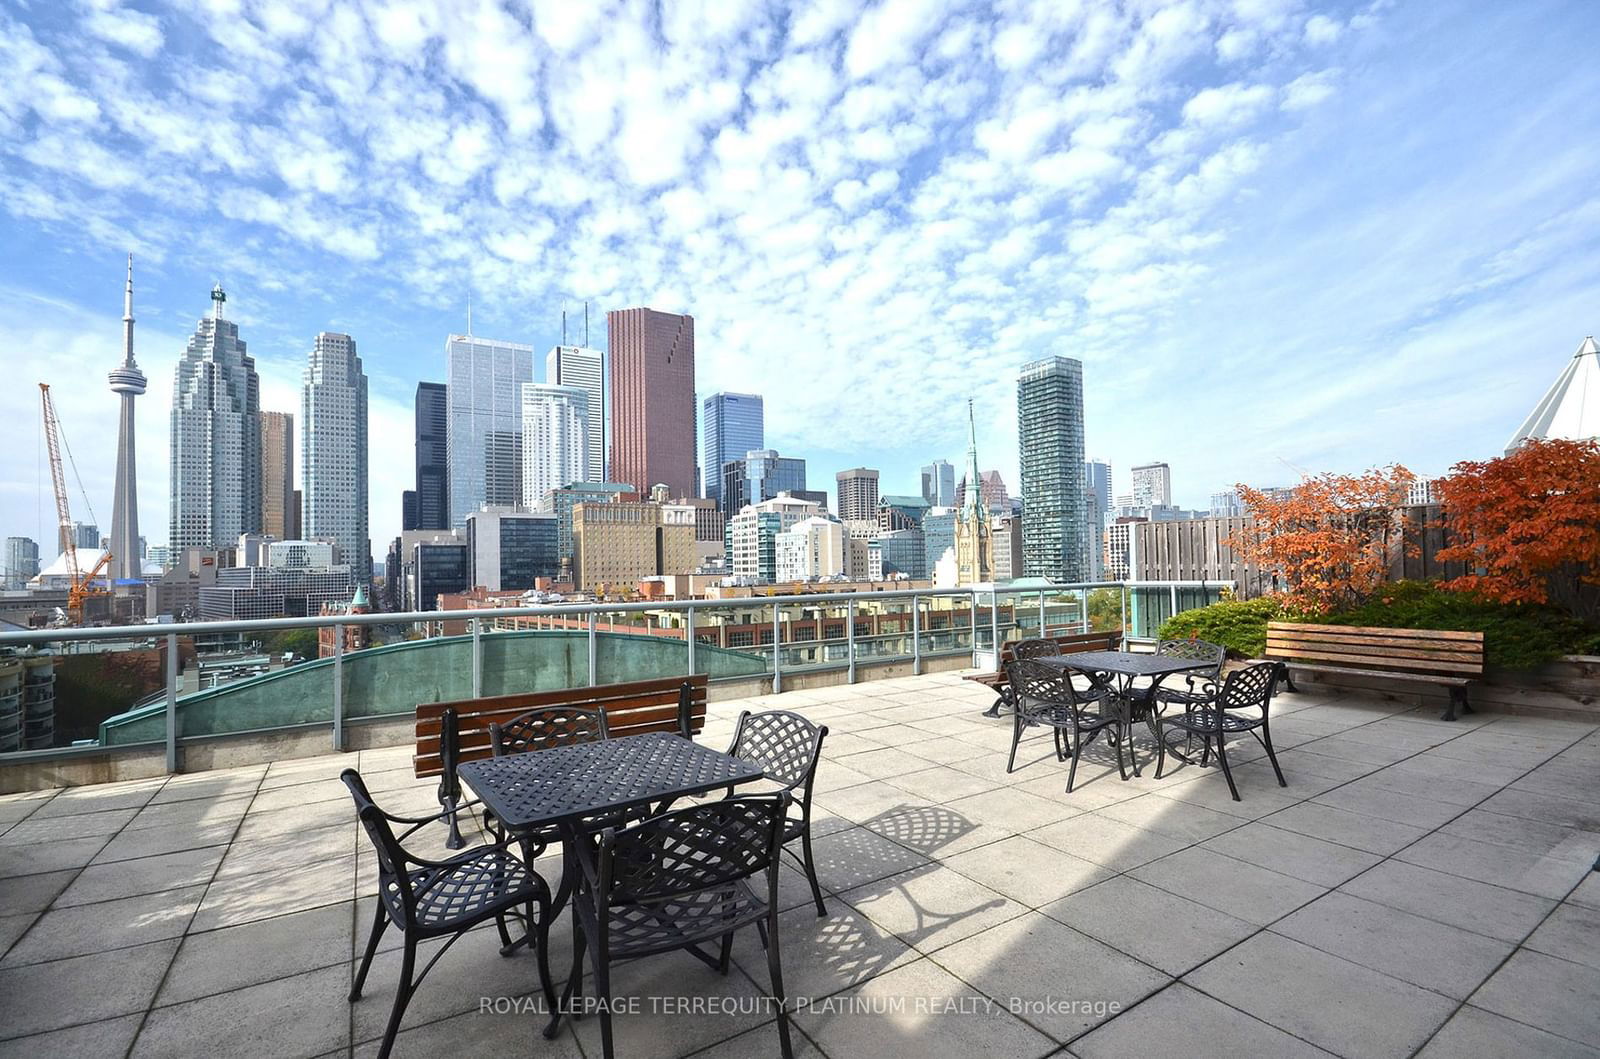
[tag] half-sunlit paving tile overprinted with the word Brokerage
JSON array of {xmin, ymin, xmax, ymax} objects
[{"xmin": 934, "ymin": 912, "xmax": 1171, "ymax": 1041}]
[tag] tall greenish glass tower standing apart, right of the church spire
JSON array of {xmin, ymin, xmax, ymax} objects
[{"xmin": 1016, "ymin": 357, "xmax": 1088, "ymax": 581}]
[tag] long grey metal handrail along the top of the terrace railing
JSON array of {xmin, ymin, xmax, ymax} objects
[{"xmin": 0, "ymin": 581, "xmax": 1232, "ymax": 646}]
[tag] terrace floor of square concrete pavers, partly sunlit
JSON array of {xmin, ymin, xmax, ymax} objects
[{"xmin": 0, "ymin": 673, "xmax": 1600, "ymax": 1059}]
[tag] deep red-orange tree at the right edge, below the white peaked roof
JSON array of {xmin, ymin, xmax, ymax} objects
[{"xmin": 1435, "ymin": 440, "xmax": 1600, "ymax": 621}]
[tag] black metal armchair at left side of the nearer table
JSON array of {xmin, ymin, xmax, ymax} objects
[{"xmin": 339, "ymin": 768, "xmax": 555, "ymax": 1059}]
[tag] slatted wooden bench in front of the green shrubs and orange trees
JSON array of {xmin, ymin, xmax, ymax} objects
[{"xmin": 1266, "ymin": 621, "xmax": 1483, "ymax": 721}]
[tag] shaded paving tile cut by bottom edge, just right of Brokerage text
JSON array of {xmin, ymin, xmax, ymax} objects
[{"xmin": 1070, "ymin": 982, "xmax": 1330, "ymax": 1059}]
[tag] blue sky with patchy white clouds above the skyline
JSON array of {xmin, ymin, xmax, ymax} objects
[{"xmin": 0, "ymin": 0, "xmax": 1600, "ymax": 555}]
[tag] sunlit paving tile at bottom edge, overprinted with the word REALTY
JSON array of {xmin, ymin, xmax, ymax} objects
[{"xmin": 797, "ymin": 960, "xmax": 1058, "ymax": 1059}]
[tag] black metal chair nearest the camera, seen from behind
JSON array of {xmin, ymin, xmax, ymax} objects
[{"xmin": 546, "ymin": 792, "xmax": 794, "ymax": 1059}]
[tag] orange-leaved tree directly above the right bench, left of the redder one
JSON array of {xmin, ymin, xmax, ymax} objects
[{"xmin": 1227, "ymin": 466, "xmax": 1416, "ymax": 617}]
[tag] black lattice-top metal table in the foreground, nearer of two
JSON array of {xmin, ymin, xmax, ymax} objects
[{"xmin": 456, "ymin": 731, "xmax": 763, "ymax": 1037}]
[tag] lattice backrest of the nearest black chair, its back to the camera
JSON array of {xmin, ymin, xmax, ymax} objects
[{"xmin": 598, "ymin": 792, "xmax": 789, "ymax": 904}]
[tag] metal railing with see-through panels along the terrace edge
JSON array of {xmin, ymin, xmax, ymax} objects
[{"xmin": 0, "ymin": 581, "xmax": 1229, "ymax": 771}]
